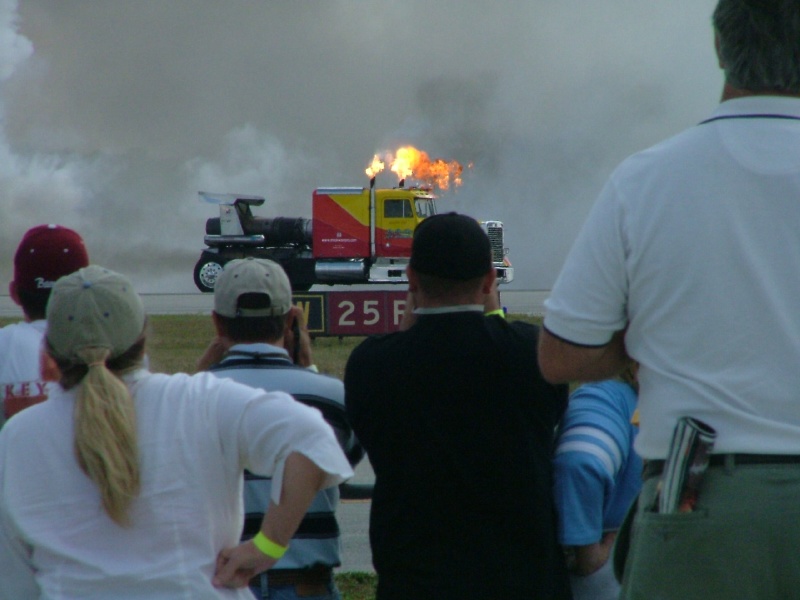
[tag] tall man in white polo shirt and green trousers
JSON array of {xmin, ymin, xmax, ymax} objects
[{"xmin": 539, "ymin": 0, "xmax": 800, "ymax": 600}]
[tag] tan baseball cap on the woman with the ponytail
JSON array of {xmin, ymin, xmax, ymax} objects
[{"xmin": 47, "ymin": 265, "xmax": 145, "ymax": 360}]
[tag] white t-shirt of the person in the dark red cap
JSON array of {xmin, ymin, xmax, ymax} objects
[{"xmin": 0, "ymin": 320, "xmax": 48, "ymax": 427}]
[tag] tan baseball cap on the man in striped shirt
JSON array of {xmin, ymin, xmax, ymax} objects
[{"xmin": 214, "ymin": 257, "xmax": 292, "ymax": 318}]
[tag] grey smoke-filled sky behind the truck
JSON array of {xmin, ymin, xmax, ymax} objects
[{"xmin": 0, "ymin": 0, "xmax": 722, "ymax": 292}]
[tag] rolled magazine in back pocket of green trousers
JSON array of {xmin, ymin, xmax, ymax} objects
[{"xmin": 658, "ymin": 417, "xmax": 717, "ymax": 513}]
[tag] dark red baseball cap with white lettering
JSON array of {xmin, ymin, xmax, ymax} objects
[{"xmin": 14, "ymin": 225, "xmax": 89, "ymax": 292}]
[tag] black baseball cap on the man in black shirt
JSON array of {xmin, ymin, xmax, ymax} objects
[{"xmin": 411, "ymin": 212, "xmax": 492, "ymax": 281}]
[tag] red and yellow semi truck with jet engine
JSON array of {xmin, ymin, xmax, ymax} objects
[{"xmin": 194, "ymin": 179, "xmax": 514, "ymax": 292}]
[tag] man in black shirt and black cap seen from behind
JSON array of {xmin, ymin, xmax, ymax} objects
[{"xmin": 345, "ymin": 213, "xmax": 570, "ymax": 600}]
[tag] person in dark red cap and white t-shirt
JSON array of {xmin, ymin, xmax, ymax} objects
[{"xmin": 0, "ymin": 225, "xmax": 89, "ymax": 427}]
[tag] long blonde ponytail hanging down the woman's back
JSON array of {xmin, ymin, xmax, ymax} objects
[{"xmin": 74, "ymin": 348, "xmax": 141, "ymax": 526}]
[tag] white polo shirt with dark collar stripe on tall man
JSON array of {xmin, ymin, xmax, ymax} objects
[{"xmin": 544, "ymin": 97, "xmax": 800, "ymax": 458}]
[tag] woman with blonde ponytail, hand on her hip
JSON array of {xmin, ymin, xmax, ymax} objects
[{"xmin": 0, "ymin": 266, "xmax": 352, "ymax": 600}]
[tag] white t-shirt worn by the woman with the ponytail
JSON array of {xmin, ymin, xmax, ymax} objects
[{"xmin": 0, "ymin": 370, "xmax": 352, "ymax": 600}]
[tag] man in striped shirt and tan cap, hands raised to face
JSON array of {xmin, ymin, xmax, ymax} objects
[{"xmin": 199, "ymin": 258, "xmax": 364, "ymax": 600}]
